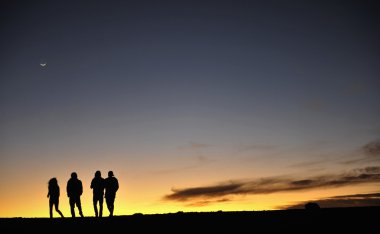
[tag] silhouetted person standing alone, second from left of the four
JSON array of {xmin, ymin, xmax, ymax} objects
[{"xmin": 66, "ymin": 172, "xmax": 83, "ymax": 218}]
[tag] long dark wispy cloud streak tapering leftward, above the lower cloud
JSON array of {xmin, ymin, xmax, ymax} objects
[{"xmin": 164, "ymin": 167, "xmax": 380, "ymax": 203}]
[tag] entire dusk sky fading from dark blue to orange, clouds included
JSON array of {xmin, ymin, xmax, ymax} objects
[{"xmin": 0, "ymin": 0, "xmax": 380, "ymax": 217}]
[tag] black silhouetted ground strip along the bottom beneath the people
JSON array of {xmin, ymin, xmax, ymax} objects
[{"xmin": 0, "ymin": 207, "xmax": 380, "ymax": 234}]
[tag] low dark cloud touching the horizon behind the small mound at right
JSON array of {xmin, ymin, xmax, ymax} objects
[{"xmin": 276, "ymin": 193, "xmax": 380, "ymax": 209}]
